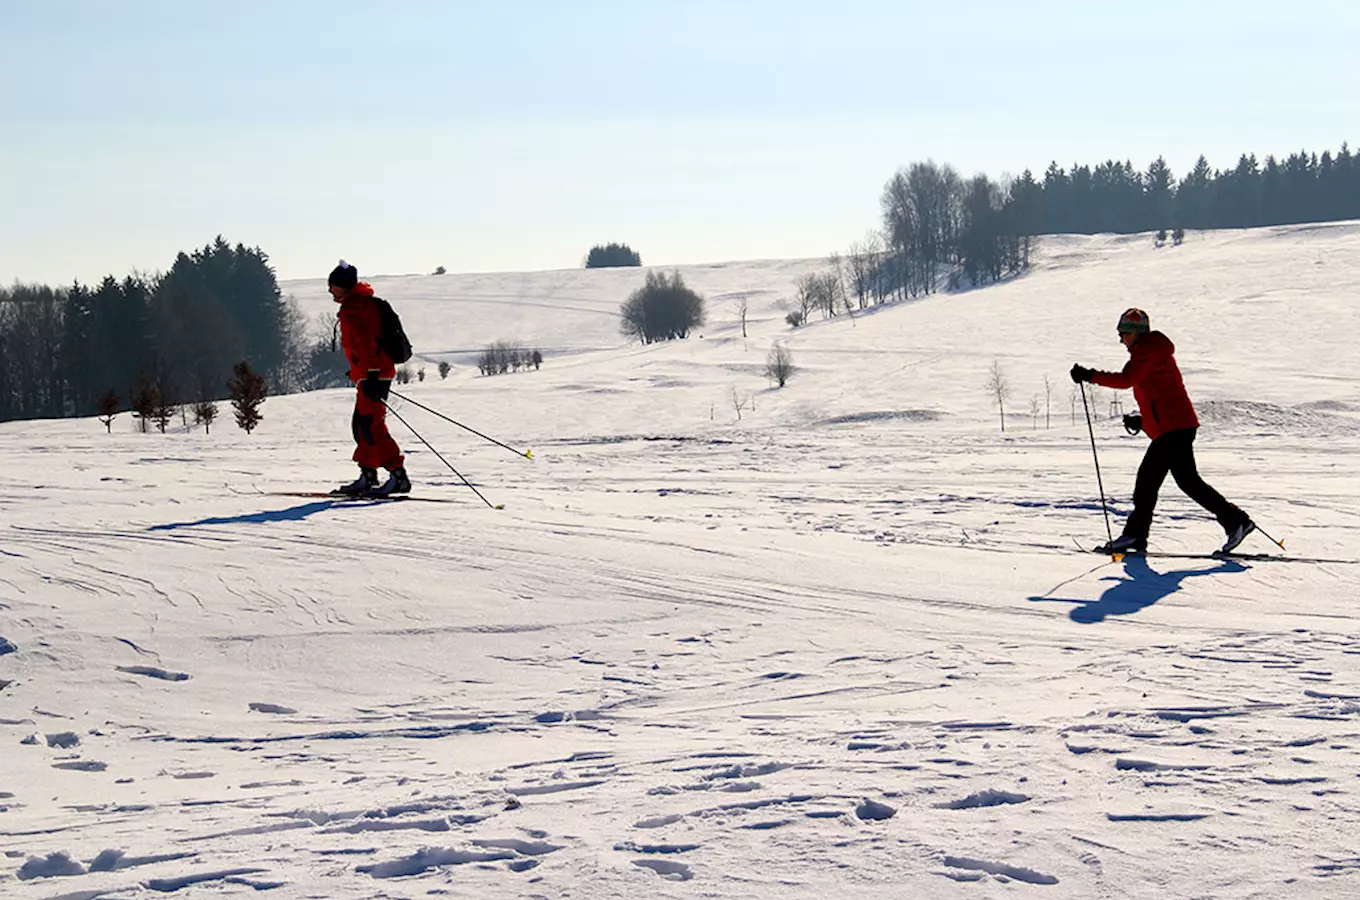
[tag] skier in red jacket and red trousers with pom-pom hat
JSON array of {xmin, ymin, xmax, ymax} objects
[{"xmin": 326, "ymin": 260, "xmax": 411, "ymax": 496}]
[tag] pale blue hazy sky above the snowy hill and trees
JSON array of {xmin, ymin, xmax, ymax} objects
[{"xmin": 0, "ymin": 0, "xmax": 1360, "ymax": 284}]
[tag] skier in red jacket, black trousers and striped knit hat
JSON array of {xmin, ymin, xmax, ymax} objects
[{"xmin": 1072, "ymin": 309, "xmax": 1257, "ymax": 553}]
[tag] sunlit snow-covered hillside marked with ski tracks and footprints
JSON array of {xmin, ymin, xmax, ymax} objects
[{"xmin": 0, "ymin": 223, "xmax": 1360, "ymax": 900}]
